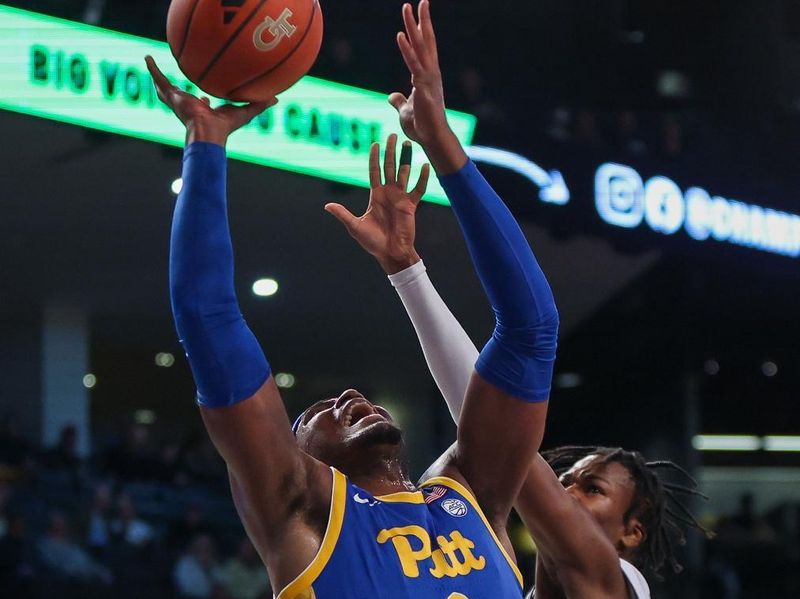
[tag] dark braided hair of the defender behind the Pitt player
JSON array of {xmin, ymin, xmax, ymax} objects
[{"xmin": 542, "ymin": 445, "xmax": 713, "ymax": 576}]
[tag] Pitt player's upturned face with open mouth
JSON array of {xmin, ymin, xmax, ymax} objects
[{"xmin": 297, "ymin": 389, "xmax": 402, "ymax": 473}]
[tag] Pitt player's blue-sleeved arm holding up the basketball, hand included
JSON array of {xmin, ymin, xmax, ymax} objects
[{"xmin": 147, "ymin": 58, "xmax": 331, "ymax": 583}]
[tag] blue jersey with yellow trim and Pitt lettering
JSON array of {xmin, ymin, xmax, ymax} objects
[{"xmin": 277, "ymin": 468, "xmax": 522, "ymax": 599}]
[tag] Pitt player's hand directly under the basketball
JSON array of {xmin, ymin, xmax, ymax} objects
[{"xmin": 144, "ymin": 56, "xmax": 278, "ymax": 146}]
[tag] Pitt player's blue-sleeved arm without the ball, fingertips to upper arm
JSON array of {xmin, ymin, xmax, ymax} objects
[{"xmin": 390, "ymin": 0, "xmax": 558, "ymax": 528}]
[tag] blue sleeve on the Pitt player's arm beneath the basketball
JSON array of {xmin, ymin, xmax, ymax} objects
[{"xmin": 169, "ymin": 142, "xmax": 270, "ymax": 408}]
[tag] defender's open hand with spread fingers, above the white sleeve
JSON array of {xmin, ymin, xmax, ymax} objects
[{"xmin": 325, "ymin": 135, "xmax": 430, "ymax": 274}]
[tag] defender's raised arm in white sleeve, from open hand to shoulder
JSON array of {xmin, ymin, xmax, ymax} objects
[{"xmin": 354, "ymin": 151, "xmax": 636, "ymax": 597}]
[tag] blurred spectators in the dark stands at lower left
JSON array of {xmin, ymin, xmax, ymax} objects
[{"xmin": 0, "ymin": 419, "xmax": 272, "ymax": 599}]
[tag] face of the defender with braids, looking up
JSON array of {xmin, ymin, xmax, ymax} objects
[{"xmin": 561, "ymin": 455, "xmax": 638, "ymax": 550}]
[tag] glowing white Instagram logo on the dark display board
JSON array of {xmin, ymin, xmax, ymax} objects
[{"xmin": 594, "ymin": 162, "xmax": 645, "ymax": 229}]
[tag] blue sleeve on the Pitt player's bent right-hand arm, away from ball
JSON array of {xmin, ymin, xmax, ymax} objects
[{"xmin": 440, "ymin": 161, "xmax": 558, "ymax": 402}]
